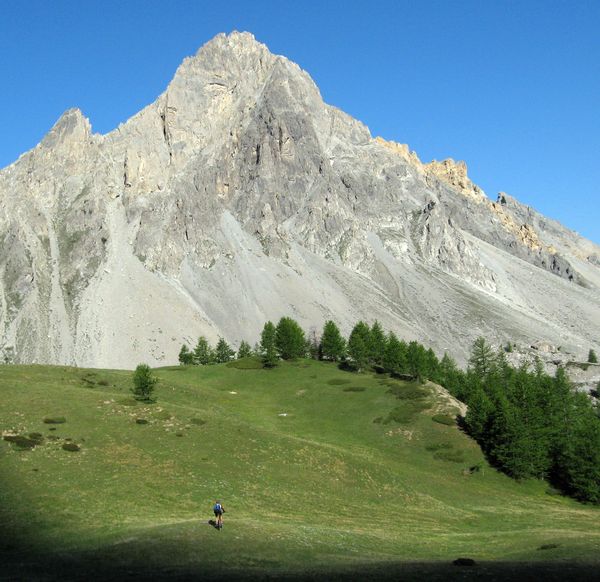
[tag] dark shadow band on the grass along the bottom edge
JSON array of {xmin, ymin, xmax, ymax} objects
[{"xmin": 0, "ymin": 519, "xmax": 598, "ymax": 582}]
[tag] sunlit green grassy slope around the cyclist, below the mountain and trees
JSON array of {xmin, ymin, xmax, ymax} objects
[{"xmin": 0, "ymin": 361, "xmax": 600, "ymax": 575}]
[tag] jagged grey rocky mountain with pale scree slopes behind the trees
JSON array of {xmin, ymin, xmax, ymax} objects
[{"xmin": 0, "ymin": 33, "xmax": 600, "ymax": 368}]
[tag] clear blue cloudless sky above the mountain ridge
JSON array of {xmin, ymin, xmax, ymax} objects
[{"xmin": 0, "ymin": 0, "xmax": 600, "ymax": 243}]
